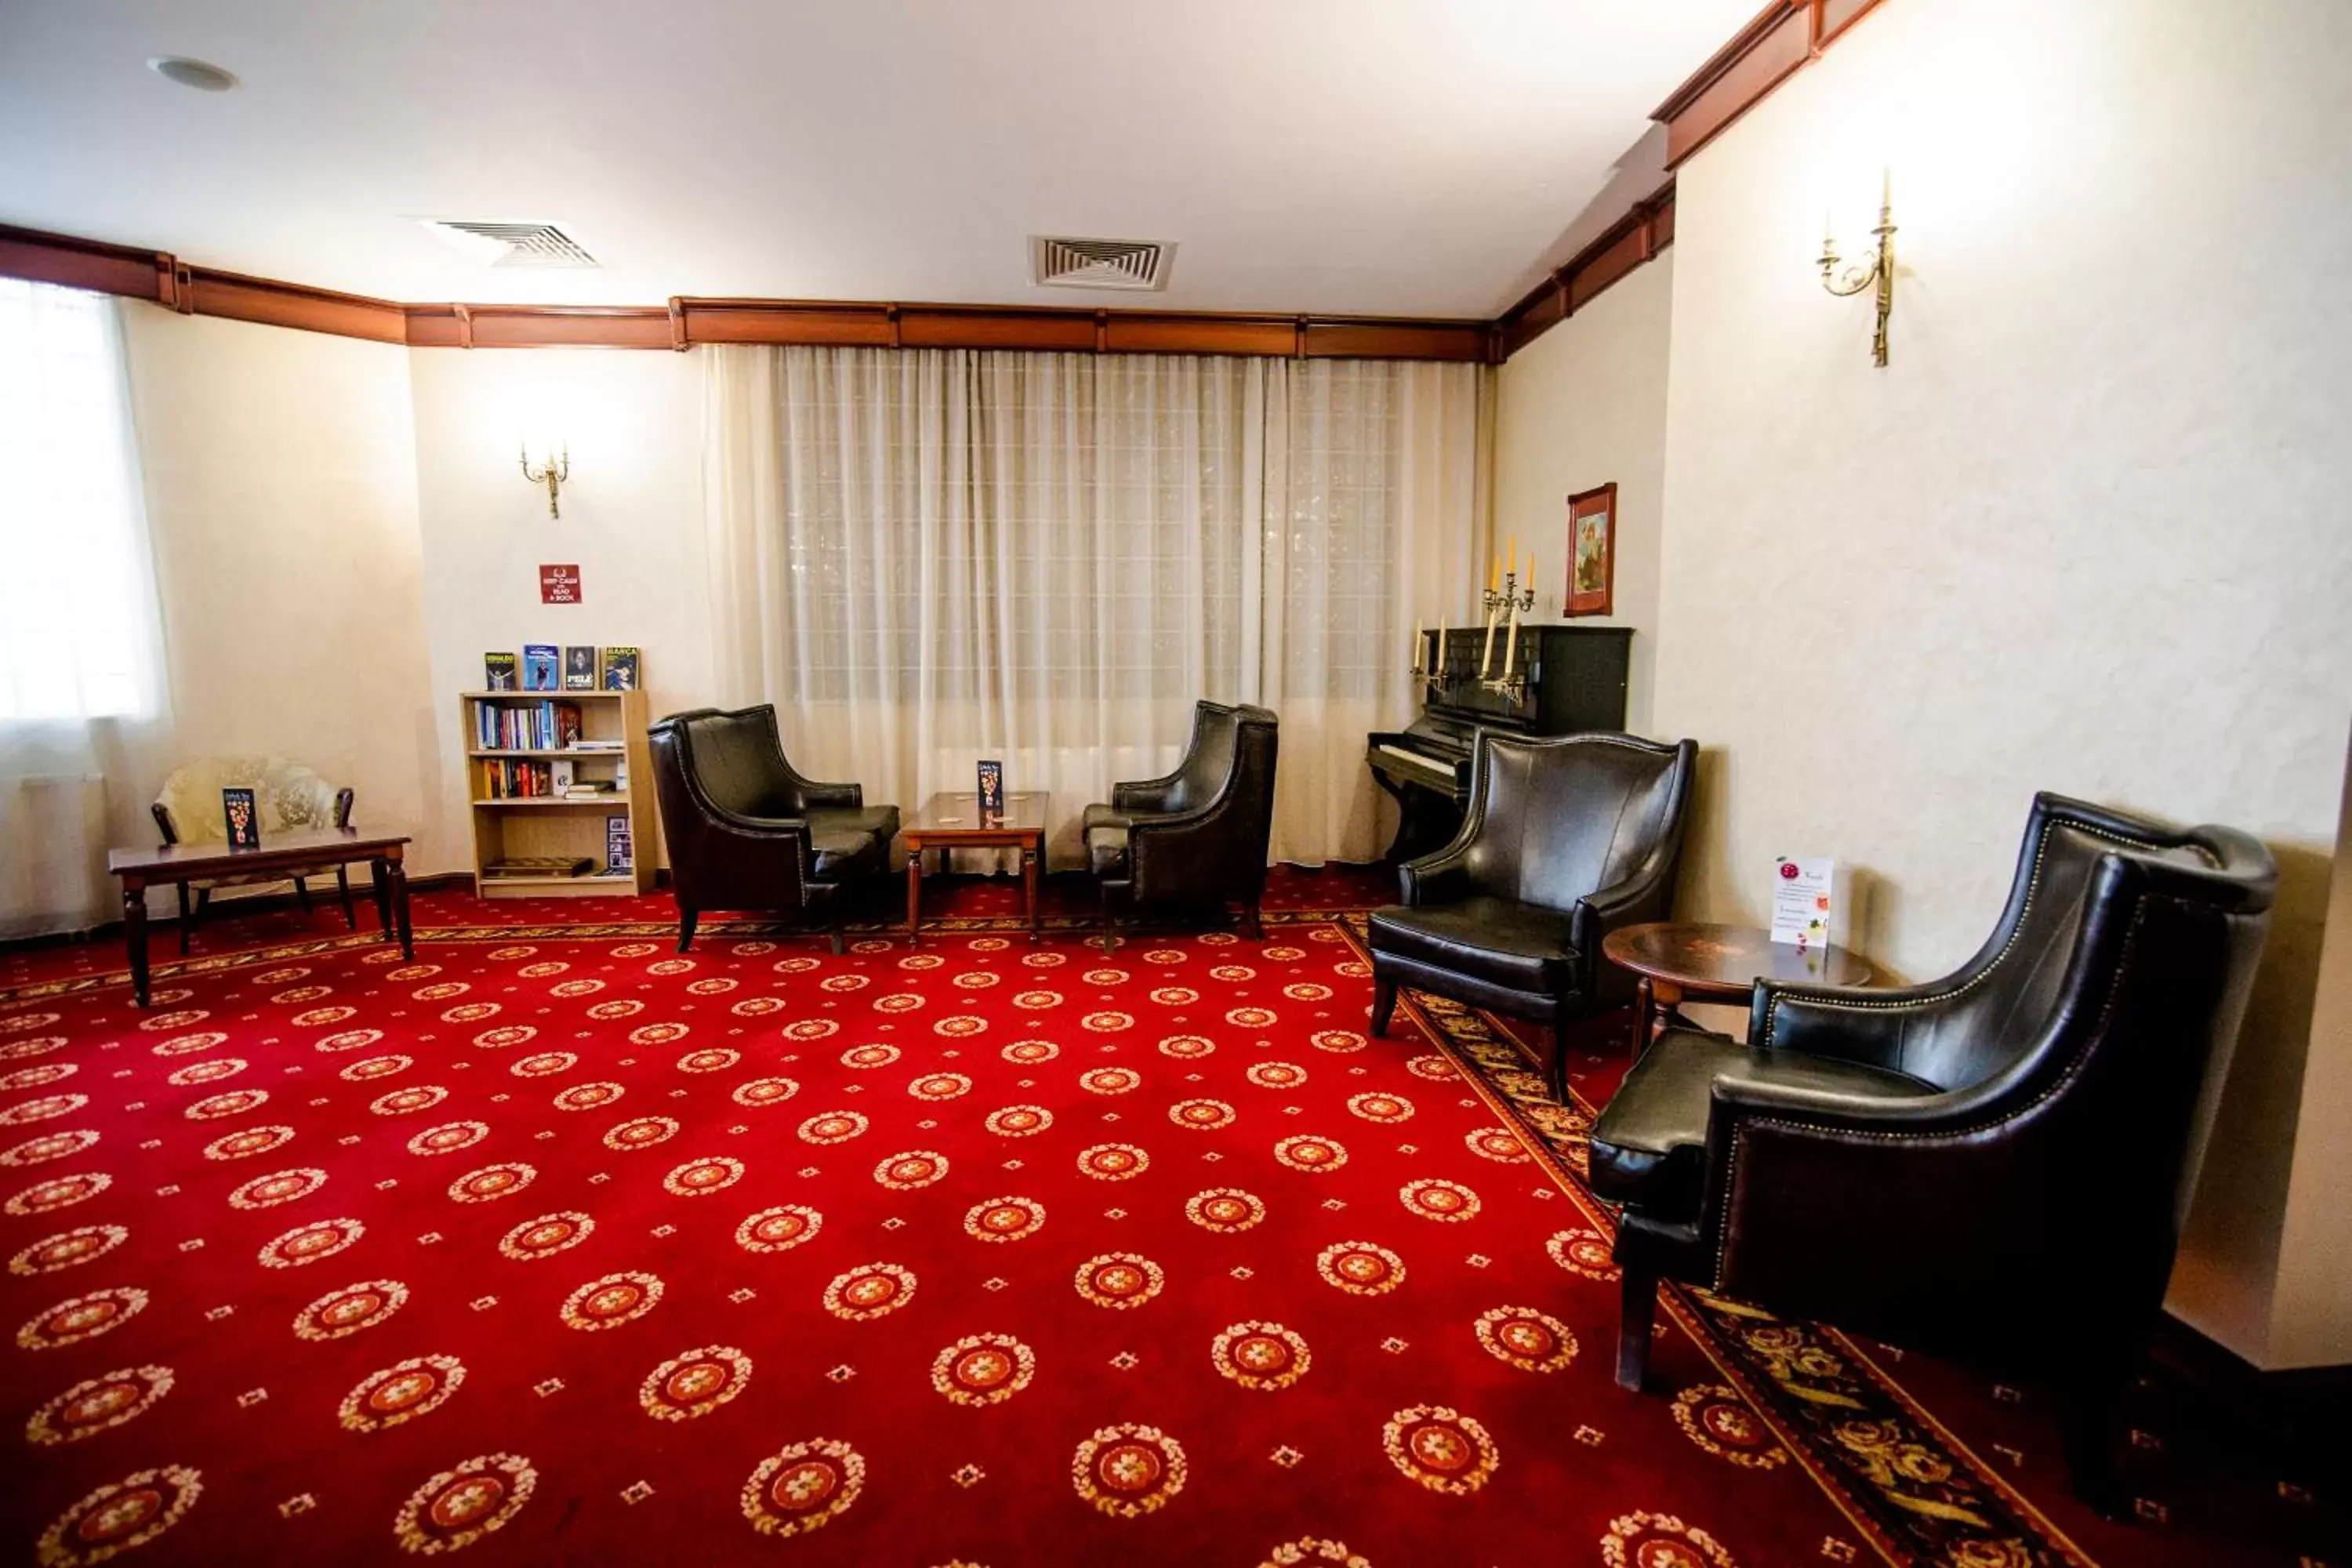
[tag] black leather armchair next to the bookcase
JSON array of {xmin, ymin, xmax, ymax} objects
[{"xmin": 647, "ymin": 703, "xmax": 898, "ymax": 952}]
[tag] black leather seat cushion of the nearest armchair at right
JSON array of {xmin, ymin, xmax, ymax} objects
[{"xmin": 1590, "ymin": 1029, "xmax": 1938, "ymax": 1222}]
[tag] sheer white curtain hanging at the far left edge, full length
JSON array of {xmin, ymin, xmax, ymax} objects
[{"xmin": 0, "ymin": 280, "xmax": 167, "ymax": 935}]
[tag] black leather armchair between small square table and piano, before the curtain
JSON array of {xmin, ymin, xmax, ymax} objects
[{"xmin": 1082, "ymin": 703, "xmax": 1279, "ymax": 952}]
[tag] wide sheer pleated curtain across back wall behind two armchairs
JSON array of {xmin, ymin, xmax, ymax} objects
[{"xmin": 706, "ymin": 348, "xmax": 1482, "ymax": 862}]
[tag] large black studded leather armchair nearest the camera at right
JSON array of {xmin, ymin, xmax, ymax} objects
[{"xmin": 1590, "ymin": 794, "xmax": 2277, "ymax": 1507}]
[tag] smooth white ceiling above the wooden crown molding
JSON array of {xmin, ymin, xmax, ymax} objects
[{"xmin": 0, "ymin": 0, "xmax": 1755, "ymax": 318}]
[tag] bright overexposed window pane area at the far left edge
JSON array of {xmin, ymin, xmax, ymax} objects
[{"xmin": 0, "ymin": 278, "xmax": 155, "ymax": 722}]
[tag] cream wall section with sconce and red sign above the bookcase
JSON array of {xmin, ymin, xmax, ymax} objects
[{"xmin": 409, "ymin": 348, "xmax": 715, "ymax": 869}]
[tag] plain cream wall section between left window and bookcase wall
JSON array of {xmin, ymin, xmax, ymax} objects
[{"xmin": 122, "ymin": 303, "xmax": 461, "ymax": 869}]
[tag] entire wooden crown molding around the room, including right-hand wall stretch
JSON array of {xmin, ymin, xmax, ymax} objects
[{"xmin": 0, "ymin": 0, "xmax": 1882, "ymax": 365}]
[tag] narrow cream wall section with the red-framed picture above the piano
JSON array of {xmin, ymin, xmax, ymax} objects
[{"xmin": 1494, "ymin": 249, "xmax": 1675, "ymax": 734}]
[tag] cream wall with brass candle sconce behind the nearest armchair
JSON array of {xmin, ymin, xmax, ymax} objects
[{"xmin": 1656, "ymin": 0, "xmax": 2352, "ymax": 1366}]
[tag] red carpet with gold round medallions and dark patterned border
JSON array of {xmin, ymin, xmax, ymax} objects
[{"xmin": 0, "ymin": 877, "xmax": 2319, "ymax": 1568}]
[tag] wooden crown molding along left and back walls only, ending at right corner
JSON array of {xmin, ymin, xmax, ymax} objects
[{"xmin": 0, "ymin": 228, "xmax": 1494, "ymax": 362}]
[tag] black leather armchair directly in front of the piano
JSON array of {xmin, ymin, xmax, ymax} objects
[{"xmin": 1371, "ymin": 731, "xmax": 1698, "ymax": 1102}]
